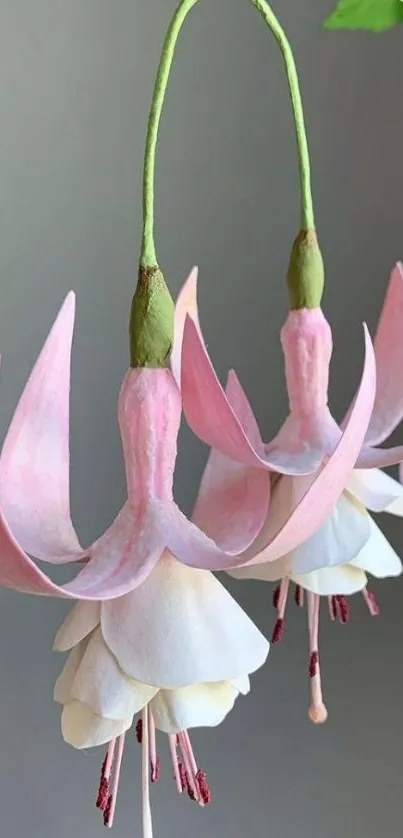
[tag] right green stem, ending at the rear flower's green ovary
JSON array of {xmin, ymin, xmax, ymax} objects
[{"xmin": 251, "ymin": 0, "xmax": 315, "ymax": 230}]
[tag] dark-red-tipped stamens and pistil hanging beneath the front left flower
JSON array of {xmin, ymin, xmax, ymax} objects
[{"xmin": 96, "ymin": 708, "xmax": 212, "ymax": 828}]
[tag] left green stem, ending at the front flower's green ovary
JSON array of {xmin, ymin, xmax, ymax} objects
[{"xmin": 140, "ymin": 0, "xmax": 198, "ymax": 267}]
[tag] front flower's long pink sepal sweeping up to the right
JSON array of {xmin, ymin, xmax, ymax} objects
[{"xmin": 175, "ymin": 327, "xmax": 376, "ymax": 570}]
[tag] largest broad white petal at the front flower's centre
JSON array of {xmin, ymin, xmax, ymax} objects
[{"xmin": 101, "ymin": 553, "xmax": 269, "ymax": 689}]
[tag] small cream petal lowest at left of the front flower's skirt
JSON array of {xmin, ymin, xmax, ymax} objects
[{"xmin": 62, "ymin": 701, "xmax": 133, "ymax": 749}]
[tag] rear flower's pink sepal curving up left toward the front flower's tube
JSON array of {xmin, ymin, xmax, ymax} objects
[{"xmin": 181, "ymin": 316, "xmax": 324, "ymax": 474}]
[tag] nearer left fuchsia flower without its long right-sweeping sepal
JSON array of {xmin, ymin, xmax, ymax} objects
[{"xmin": 0, "ymin": 272, "xmax": 269, "ymax": 834}]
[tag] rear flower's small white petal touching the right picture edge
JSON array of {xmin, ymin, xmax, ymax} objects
[{"xmin": 347, "ymin": 468, "xmax": 403, "ymax": 517}]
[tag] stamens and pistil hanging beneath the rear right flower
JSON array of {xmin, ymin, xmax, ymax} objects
[{"xmin": 271, "ymin": 577, "xmax": 379, "ymax": 724}]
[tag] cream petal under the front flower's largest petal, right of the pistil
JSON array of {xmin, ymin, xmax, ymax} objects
[{"xmin": 150, "ymin": 681, "xmax": 239, "ymax": 733}]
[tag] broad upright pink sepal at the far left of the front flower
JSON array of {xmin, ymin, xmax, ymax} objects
[{"xmin": 0, "ymin": 292, "xmax": 82, "ymax": 563}]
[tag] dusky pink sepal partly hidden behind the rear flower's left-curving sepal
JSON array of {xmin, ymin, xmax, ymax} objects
[{"xmin": 192, "ymin": 370, "xmax": 270, "ymax": 553}]
